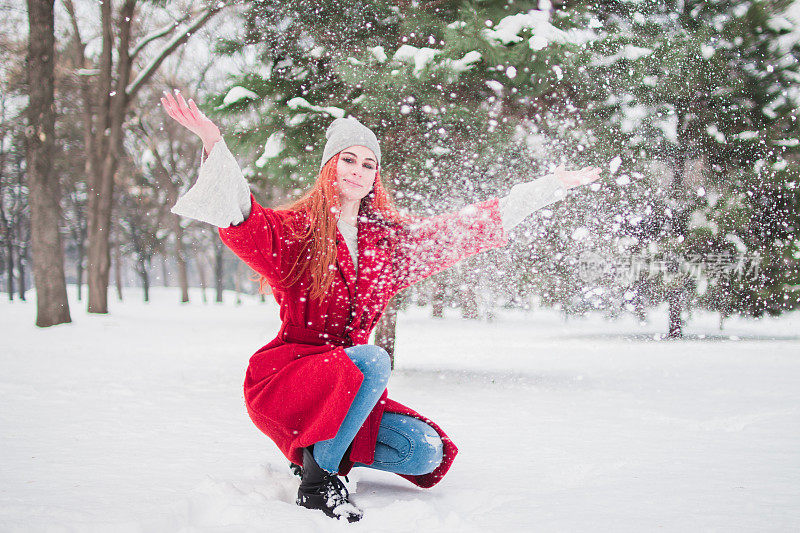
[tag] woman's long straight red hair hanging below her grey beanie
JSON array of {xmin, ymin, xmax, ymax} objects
[{"xmin": 259, "ymin": 152, "xmax": 410, "ymax": 299}]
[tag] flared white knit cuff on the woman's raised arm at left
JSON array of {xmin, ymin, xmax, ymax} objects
[{"xmin": 171, "ymin": 140, "xmax": 250, "ymax": 228}]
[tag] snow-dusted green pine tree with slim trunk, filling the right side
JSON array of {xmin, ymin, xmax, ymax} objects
[{"xmin": 568, "ymin": 1, "xmax": 798, "ymax": 336}]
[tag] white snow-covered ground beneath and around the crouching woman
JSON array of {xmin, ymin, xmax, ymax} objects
[{"xmin": 0, "ymin": 289, "xmax": 800, "ymax": 533}]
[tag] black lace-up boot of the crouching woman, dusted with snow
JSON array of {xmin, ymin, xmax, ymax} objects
[{"xmin": 296, "ymin": 448, "xmax": 364, "ymax": 522}]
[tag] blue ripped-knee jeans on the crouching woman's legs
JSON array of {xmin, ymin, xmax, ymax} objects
[{"xmin": 314, "ymin": 344, "xmax": 442, "ymax": 475}]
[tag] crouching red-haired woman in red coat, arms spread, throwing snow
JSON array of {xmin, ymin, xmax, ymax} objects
[{"xmin": 161, "ymin": 91, "xmax": 599, "ymax": 522}]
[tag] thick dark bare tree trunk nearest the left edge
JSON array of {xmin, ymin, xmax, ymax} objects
[{"xmin": 25, "ymin": 0, "xmax": 72, "ymax": 327}]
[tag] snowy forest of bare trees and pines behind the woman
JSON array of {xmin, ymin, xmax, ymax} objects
[{"xmin": 0, "ymin": 0, "xmax": 800, "ymax": 336}]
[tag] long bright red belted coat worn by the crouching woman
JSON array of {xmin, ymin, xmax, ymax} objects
[{"xmin": 219, "ymin": 195, "xmax": 508, "ymax": 487}]
